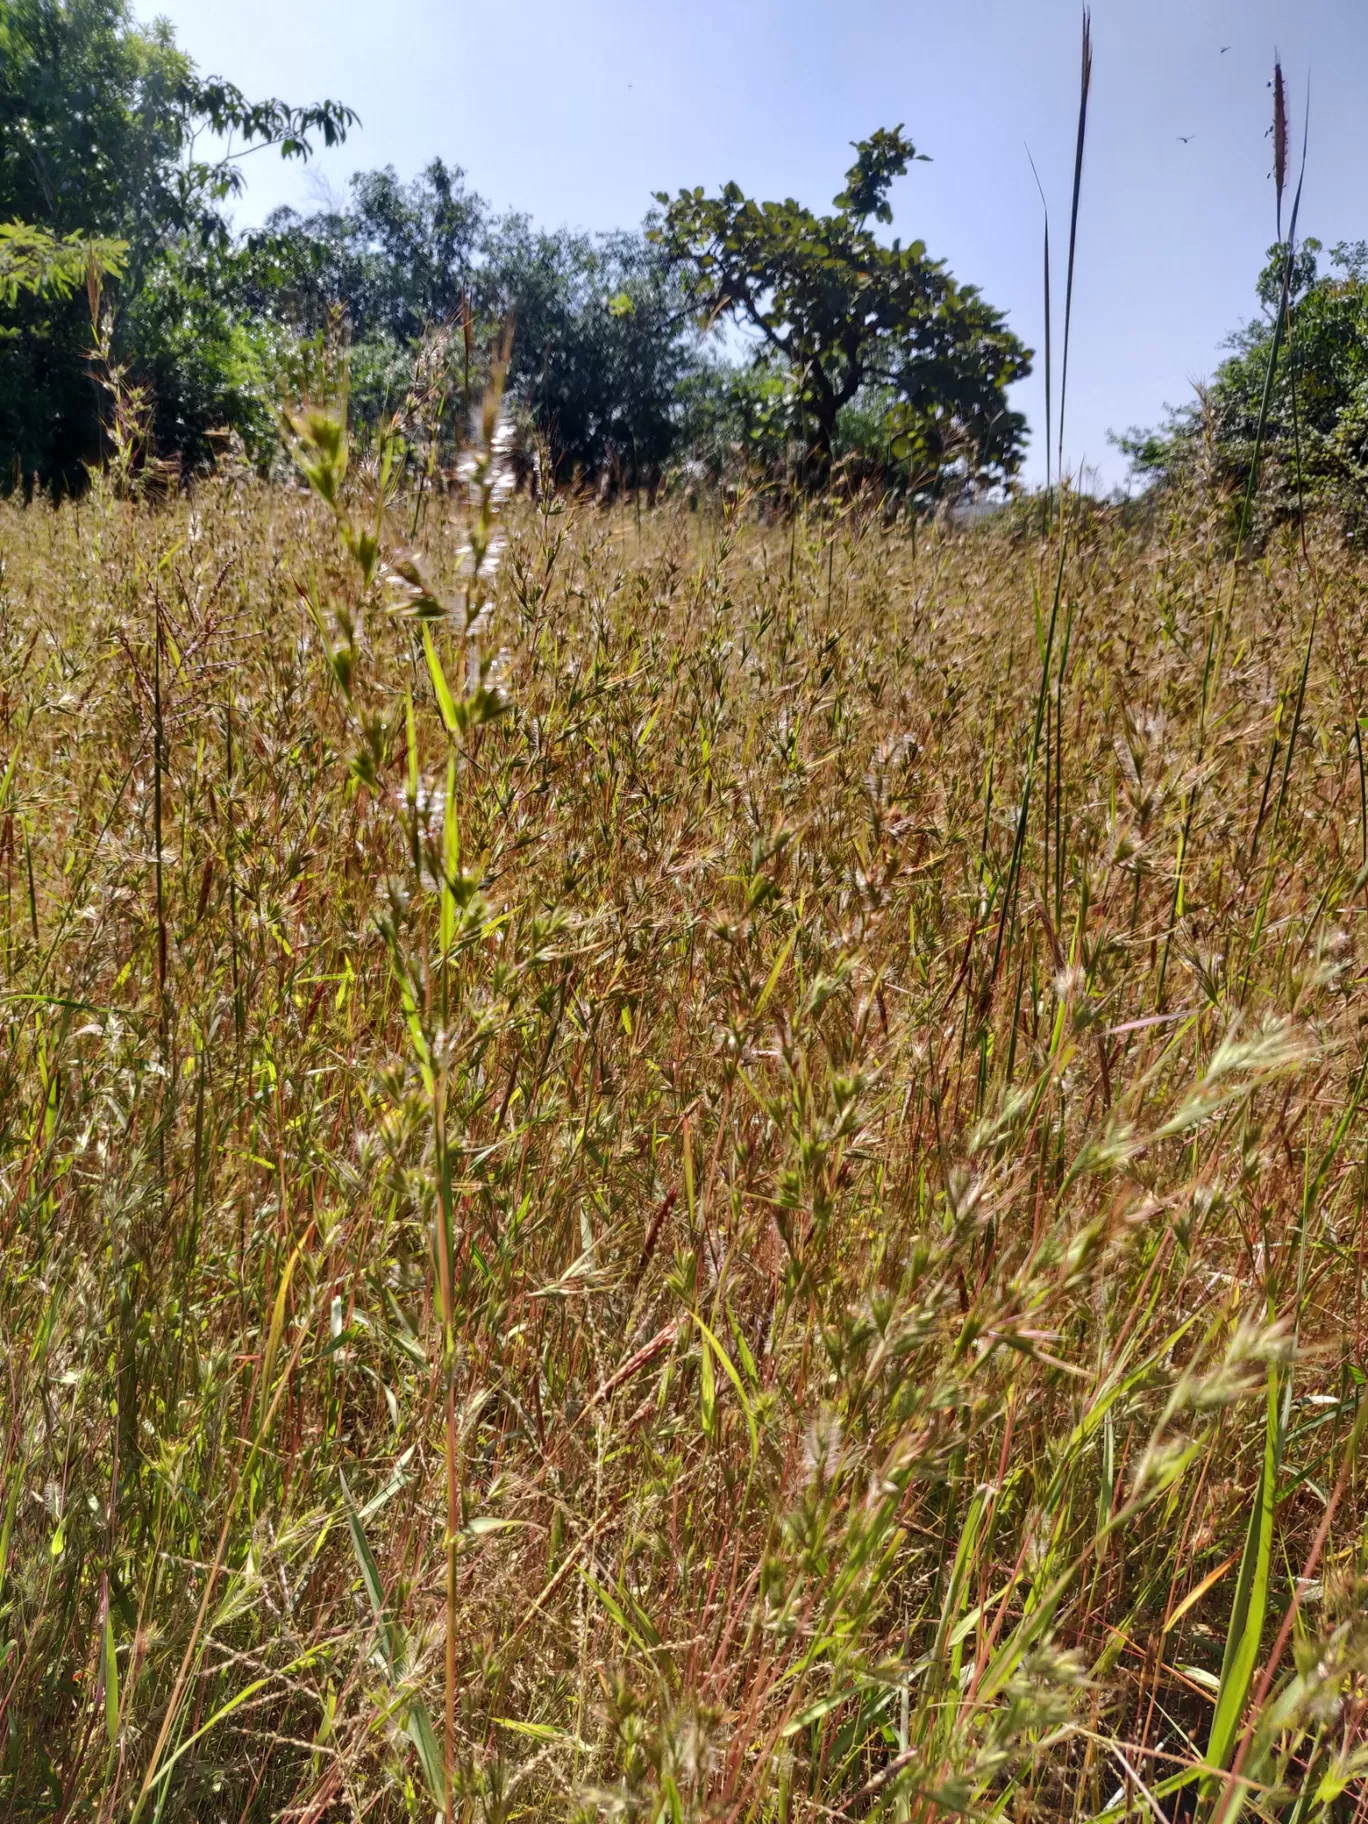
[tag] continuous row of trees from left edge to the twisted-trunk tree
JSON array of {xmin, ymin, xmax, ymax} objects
[{"xmin": 0, "ymin": 0, "xmax": 1031, "ymax": 498}]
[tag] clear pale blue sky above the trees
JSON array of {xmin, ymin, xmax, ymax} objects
[{"xmin": 135, "ymin": 0, "xmax": 1368, "ymax": 485}]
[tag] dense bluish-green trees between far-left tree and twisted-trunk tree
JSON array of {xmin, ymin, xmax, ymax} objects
[{"xmin": 237, "ymin": 182, "xmax": 697, "ymax": 485}]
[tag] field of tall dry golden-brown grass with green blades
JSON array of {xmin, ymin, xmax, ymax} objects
[{"xmin": 0, "ymin": 445, "xmax": 1368, "ymax": 1824}]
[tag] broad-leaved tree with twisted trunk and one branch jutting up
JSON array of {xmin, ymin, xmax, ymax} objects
[{"xmin": 655, "ymin": 128, "xmax": 1031, "ymax": 492}]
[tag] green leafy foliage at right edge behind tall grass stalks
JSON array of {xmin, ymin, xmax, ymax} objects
[{"xmin": 1118, "ymin": 241, "xmax": 1368, "ymax": 536}]
